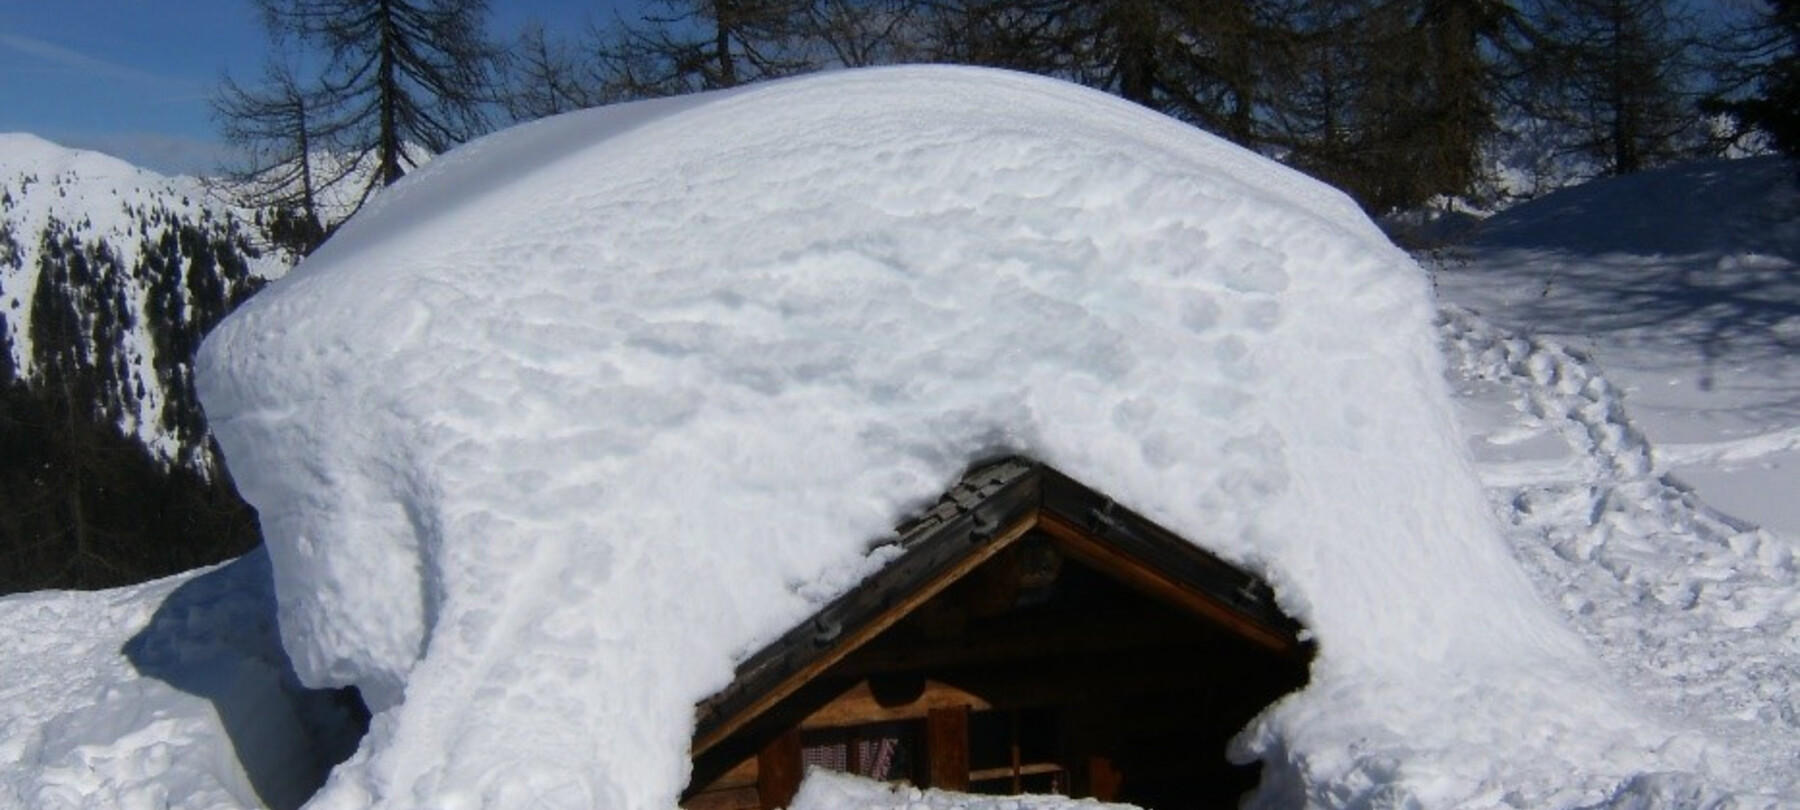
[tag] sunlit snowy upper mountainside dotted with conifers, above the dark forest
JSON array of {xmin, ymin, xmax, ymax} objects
[{"xmin": 0, "ymin": 133, "xmax": 281, "ymax": 470}]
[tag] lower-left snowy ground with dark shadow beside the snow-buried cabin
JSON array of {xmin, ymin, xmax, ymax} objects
[{"xmin": 0, "ymin": 551, "xmax": 356, "ymax": 810}]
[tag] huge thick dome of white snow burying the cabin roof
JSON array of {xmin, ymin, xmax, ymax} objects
[{"xmin": 202, "ymin": 68, "xmax": 1705, "ymax": 808}]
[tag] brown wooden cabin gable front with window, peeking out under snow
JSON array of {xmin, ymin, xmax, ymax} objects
[{"xmin": 684, "ymin": 459, "xmax": 1310, "ymax": 810}]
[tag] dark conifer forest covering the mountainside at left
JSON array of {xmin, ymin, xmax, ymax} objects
[{"xmin": 0, "ymin": 218, "xmax": 257, "ymax": 594}]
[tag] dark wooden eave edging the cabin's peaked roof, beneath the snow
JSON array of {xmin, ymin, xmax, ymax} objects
[{"xmin": 691, "ymin": 459, "xmax": 1301, "ymax": 756}]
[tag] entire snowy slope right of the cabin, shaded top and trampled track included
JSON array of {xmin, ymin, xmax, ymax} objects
[{"xmin": 1436, "ymin": 158, "xmax": 1800, "ymax": 805}]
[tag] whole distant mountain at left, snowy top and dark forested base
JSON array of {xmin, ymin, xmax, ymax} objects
[{"xmin": 0, "ymin": 133, "xmax": 275, "ymax": 592}]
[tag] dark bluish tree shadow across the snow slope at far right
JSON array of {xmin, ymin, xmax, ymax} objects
[{"xmin": 1469, "ymin": 158, "xmax": 1800, "ymax": 418}]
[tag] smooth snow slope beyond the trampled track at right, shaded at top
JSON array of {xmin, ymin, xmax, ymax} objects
[{"xmin": 1436, "ymin": 158, "xmax": 1800, "ymax": 535}]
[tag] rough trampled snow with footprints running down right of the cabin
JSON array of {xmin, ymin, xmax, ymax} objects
[{"xmin": 1444, "ymin": 308, "xmax": 1800, "ymax": 806}]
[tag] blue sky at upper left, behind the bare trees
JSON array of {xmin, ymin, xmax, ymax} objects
[{"xmin": 0, "ymin": 0, "xmax": 619, "ymax": 173}]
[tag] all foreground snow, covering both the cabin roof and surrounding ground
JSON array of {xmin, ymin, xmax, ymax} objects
[{"xmin": 0, "ymin": 72, "xmax": 1800, "ymax": 810}]
